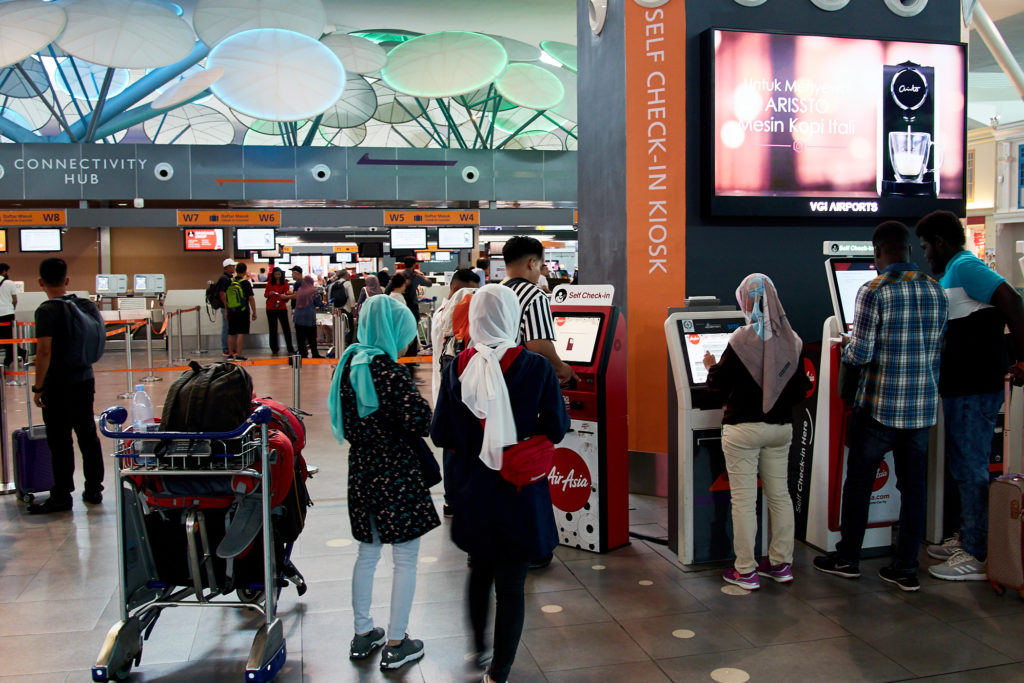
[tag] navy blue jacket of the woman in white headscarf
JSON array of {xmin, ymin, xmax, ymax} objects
[{"xmin": 430, "ymin": 350, "xmax": 569, "ymax": 561}]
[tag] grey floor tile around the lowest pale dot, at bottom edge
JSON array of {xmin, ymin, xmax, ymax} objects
[{"xmin": 657, "ymin": 636, "xmax": 910, "ymax": 683}]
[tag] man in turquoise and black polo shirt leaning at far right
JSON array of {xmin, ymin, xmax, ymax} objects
[{"xmin": 914, "ymin": 211, "xmax": 1024, "ymax": 581}]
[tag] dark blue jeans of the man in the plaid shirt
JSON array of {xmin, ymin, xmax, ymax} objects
[{"xmin": 836, "ymin": 408, "xmax": 930, "ymax": 571}]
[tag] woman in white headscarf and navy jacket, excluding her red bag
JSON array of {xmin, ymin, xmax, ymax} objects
[{"xmin": 430, "ymin": 285, "xmax": 569, "ymax": 683}]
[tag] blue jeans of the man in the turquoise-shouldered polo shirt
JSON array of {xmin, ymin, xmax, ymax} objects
[{"xmin": 942, "ymin": 391, "xmax": 1002, "ymax": 560}]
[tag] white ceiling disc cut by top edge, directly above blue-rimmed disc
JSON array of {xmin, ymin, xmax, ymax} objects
[{"xmin": 193, "ymin": 0, "xmax": 327, "ymax": 47}]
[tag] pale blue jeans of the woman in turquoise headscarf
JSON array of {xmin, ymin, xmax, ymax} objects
[{"xmin": 352, "ymin": 517, "xmax": 420, "ymax": 640}]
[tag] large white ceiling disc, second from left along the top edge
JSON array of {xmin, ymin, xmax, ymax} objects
[{"xmin": 57, "ymin": 0, "xmax": 196, "ymax": 69}]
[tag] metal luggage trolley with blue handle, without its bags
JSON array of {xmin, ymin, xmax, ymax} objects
[{"xmin": 92, "ymin": 407, "xmax": 290, "ymax": 681}]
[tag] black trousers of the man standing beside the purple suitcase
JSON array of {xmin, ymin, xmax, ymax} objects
[{"xmin": 43, "ymin": 380, "xmax": 103, "ymax": 502}]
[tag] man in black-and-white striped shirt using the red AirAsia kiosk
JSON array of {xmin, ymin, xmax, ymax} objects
[{"xmin": 502, "ymin": 236, "xmax": 580, "ymax": 384}]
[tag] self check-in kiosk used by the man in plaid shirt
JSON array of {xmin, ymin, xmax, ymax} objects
[{"xmin": 806, "ymin": 257, "xmax": 900, "ymax": 551}]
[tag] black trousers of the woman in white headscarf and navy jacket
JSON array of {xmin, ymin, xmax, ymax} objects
[{"xmin": 469, "ymin": 557, "xmax": 527, "ymax": 683}]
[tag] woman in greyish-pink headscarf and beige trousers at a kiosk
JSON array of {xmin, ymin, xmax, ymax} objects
[{"xmin": 703, "ymin": 272, "xmax": 810, "ymax": 591}]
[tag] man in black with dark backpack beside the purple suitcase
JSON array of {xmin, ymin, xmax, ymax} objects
[{"xmin": 29, "ymin": 258, "xmax": 106, "ymax": 514}]
